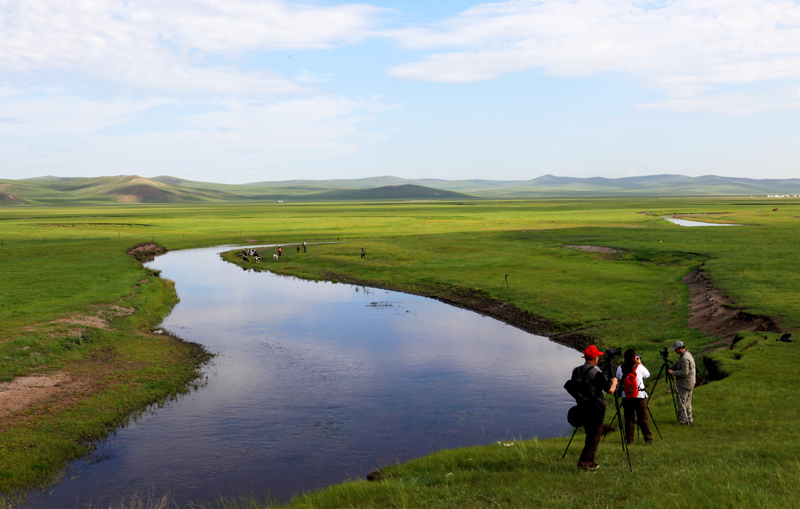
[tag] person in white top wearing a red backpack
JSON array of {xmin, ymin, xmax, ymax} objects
[{"xmin": 617, "ymin": 348, "xmax": 653, "ymax": 444}]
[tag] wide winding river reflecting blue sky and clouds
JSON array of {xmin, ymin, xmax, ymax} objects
[{"xmin": 31, "ymin": 246, "xmax": 582, "ymax": 507}]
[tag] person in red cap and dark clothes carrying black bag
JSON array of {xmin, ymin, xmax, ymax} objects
[{"xmin": 572, "ymin": 345, "xmax": 617, "ymax": 471}]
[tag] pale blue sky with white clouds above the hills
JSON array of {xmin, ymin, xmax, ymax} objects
[{"xmin": 0, "ymin": 0, "xmax": 800, "ymax": 184}]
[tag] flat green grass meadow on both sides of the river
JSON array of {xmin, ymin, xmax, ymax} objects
[{"xmin": 0, "ymin": 197, "xmax": 800, "ymax": 507}]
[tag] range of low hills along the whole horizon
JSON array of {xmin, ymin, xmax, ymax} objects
[{"xmin": 0, "ymin": 175, "xmax": 800, "ymax": 206}]
